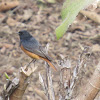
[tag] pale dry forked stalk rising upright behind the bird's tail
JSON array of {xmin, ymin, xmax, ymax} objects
[{"xmin": 39, "ymin": 45, "xmax": 55, "ymax": 100}]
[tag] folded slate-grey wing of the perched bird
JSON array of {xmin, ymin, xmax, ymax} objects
[{"xmin": 22, "ymin": 39, "xmax": 52, "ymax": 61}]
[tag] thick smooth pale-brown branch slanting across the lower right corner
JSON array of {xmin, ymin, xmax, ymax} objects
[{"xmin": 73, "ymin": 62, "xmax": 100, "ymax": 100}]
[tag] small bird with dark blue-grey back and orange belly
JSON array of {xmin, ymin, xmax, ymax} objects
[{"xmin": 17, "ymin": 30, "xmax": 57, "ymax": 71}]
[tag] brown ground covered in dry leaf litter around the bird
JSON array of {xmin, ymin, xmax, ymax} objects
[{"xmin": 0, "ymin": 0, "xmax": 100, "ymax": 100}]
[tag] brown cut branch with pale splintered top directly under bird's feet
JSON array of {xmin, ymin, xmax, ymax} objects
[{"xmin": 10, "ymin": 66, "xmax": 37, "ymax": 100}]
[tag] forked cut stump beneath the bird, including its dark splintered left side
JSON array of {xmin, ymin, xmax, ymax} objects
[{"xmin": 0, "ymin": 63, "xmax": 37, "ymax": 100}]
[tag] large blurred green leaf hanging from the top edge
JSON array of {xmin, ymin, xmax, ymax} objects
[{"xmin": 55, "ymin": 0, "xmax": 94, "ymax": 39}]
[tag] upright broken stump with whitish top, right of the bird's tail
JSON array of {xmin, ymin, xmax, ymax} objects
[{"xmin": 59, "ymin": 59, "xmax": 71, "ymax": 100}]
